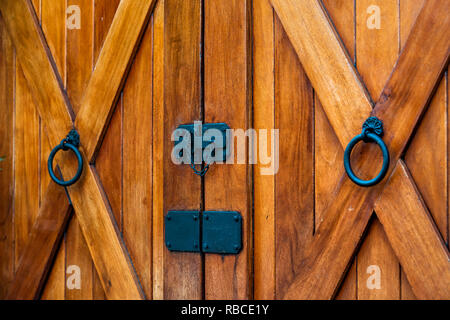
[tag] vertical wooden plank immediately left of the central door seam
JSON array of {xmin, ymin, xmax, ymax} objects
[{"xmin": 164, "ymin": 0, "xmax": 202, "ymax": 299}]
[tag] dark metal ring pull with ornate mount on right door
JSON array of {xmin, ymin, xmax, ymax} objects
[{"xmin": 344, "ymin": 117, "xmax": 390, "ymax": 187}]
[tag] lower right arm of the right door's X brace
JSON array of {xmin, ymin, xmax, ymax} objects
[{"xmin": 375, "ymin": 161, "xmax": 450, "ymax": 299}]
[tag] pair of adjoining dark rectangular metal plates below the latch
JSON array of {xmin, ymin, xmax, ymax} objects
[{"xmin": 165, "ymin": 211, "xmax": 242, "ymax": 254}]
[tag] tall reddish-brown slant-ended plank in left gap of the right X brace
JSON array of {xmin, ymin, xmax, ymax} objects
[{"xmin": 275, "ymin": 18, "xmax": 314, "ymax": 297}]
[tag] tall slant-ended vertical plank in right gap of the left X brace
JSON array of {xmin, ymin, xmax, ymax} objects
[{"xmin": 122, "ymin": 19, "xmax": 153, "ymax": 299}]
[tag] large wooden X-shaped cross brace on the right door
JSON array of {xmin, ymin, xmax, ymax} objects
[{"xmin": 271, "ymin": 0, "xmax": 450, "ymax": 299}]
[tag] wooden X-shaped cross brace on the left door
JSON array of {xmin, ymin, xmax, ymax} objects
[{"xmin": 0, "ymin": 0, "xmax": 156, "ymax": 299}]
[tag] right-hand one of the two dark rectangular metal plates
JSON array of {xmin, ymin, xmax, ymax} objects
[{"xmin": 202, "ymin": 211, "xmax": 242, "ymax": 254}]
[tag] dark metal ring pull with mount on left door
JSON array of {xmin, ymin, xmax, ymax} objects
[{"xmin": 47, "ymin": 130, "xmax": 83, "ymax": 187}]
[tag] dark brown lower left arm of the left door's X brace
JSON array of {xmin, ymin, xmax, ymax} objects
[{"xmin": 7, "ymin": 183, "xmax": 71, "ymax": 300}]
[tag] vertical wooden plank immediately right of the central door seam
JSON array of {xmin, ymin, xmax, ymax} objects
[{"xmin": 204, "ymin": 0, "xmax": 253, "ymax": 299}]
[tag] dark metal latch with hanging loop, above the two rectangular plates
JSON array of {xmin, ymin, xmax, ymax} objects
[{"xmin": 175, "ymin": 122, "xmax": 230, "ymax": 177}]
